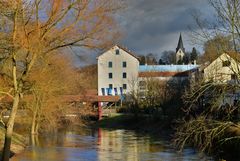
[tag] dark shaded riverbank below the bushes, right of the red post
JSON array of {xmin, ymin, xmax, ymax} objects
[{"xmin": 95, "ymin": 114, "xmax": 174, "ymax": 138}]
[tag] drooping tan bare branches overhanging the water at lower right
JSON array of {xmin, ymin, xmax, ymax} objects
[{"xmin": 174, "ymin": 116, "xmax": 240, "ymax": 152}]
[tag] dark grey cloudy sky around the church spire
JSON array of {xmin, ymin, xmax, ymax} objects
[{"xmin": 74, "ymin": 0, "xmax": 213, "ymax": 65}]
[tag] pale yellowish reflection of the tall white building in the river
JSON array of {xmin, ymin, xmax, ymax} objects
[{"xmin": 98, "ymin": 130, "xmax": 151, "ymax": 161}]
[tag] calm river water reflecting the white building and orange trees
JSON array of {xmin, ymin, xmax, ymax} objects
[{"xmin": 11, "ymin": 129, "xmax": 212, "ymax": 161}]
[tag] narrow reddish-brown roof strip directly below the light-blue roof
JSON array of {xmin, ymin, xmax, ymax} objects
[{"xmin": 138, "ymin": 72, "xmax": 189, "ymax": 77}]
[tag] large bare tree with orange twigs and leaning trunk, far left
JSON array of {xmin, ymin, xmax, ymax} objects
[{"xmin": 0, "ymin": 0, "xmax": 122, "ymax": 161}]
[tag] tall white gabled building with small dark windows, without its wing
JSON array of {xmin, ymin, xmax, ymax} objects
[{"xmin": 97, "ymin": 45, "xmax": 139, "ymax": 96}]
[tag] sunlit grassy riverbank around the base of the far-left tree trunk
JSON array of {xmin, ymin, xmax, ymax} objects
[{"xmin": 0, "ymin": 127, "xmax": 27, "ymax": 157}]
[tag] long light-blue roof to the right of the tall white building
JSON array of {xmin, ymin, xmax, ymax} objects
[{"xmin": 138, "ymin": 65, "xmax": 199, "ymax": 72}]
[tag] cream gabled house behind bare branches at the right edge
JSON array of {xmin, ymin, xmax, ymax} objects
[{"xmin": 203, "ymin": 53, "xmax": 240, "ymax": 83}]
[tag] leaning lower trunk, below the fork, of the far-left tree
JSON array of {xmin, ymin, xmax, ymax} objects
[{"xmin": 2, "ymin": 93, "xmax": 20, "ymax": 161}]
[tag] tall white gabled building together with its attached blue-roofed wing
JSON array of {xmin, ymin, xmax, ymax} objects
[{"xmin": 97, "ymin": 45, "xmax": 198, "ymax": 96}]
